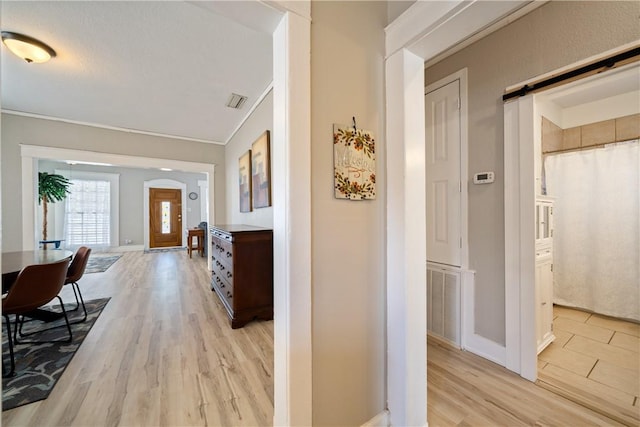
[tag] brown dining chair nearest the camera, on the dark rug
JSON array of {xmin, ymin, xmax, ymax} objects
[{"xmin": 2, "ymin": 259, "xmax": 73, "ymax": 377}]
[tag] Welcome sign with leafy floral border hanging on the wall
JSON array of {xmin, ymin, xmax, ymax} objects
[{"xmin": 333, "ymin": 124, "xmax": 376, "ymax": 200}]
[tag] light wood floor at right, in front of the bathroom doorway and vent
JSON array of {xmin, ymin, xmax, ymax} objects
[{"xmin": 427, "ymin": 337, "xmax": 622, "ymax": 427}]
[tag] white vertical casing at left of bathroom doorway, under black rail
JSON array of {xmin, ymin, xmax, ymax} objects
[{"xmin": 504, "ymin": 95, "xmax": 538, "ymax": 381}]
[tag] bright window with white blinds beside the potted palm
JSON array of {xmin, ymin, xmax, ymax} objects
[{"xmin": 64, "ymin": 179, "xmax": 111, "ymax": 246}]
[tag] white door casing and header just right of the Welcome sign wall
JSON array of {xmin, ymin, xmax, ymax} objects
[{"xmin": 385, "ymin": 1, "xmax": 530, "ymax": 425}]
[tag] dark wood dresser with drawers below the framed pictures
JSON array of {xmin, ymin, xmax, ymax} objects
[{"xmin": 211, "ymin": 225, "xmax": 273, "ymax": 329}]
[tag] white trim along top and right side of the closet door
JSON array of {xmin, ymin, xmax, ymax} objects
[{"xmin": 424, "ymin": 68, "xmax": 469, "ymax": 269}]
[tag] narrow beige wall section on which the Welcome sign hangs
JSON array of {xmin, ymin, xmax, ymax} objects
[{"xmin": 311, "ymin": 1, "xmax": 387, "ymax": 426}]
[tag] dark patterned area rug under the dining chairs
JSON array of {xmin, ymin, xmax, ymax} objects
[{"xmin": 2, "ymin": 298, "xmax": 110, "ymax": 411}]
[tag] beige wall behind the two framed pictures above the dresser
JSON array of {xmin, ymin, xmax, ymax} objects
[{"xmin": 225, "ymin": 91, "xmax": 273, "ymax": 228}]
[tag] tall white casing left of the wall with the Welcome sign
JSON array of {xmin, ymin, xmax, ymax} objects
[{"xmin": 271, "ymin": 13, "xmax": 312, "ymax": 426}]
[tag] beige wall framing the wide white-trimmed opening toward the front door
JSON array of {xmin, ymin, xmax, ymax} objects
[{"xmin": 0, "ymin": 114, "xmax": 225, "ymax": 252}]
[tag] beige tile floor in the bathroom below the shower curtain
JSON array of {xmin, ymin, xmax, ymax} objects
[{"xmin": 538, "ymin": 306, "xmax": 640, "ymax": 426}]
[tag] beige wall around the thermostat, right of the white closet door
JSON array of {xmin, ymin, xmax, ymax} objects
[{"xmin": 425, "ymin": 1, "xmax": 640, "ymax": 344}]
